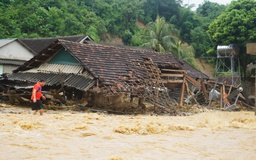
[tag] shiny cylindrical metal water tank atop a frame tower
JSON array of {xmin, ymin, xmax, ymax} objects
[{"xmin": 217, "ymin": 45, "xmax": 239, "ymax": 56}]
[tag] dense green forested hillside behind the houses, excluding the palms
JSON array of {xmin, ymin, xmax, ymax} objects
[{"xmin": 0, "ymin": 0, "xmax": 225, "ymax": 49}]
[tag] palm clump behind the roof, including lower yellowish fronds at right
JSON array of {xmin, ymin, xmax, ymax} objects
[{"xmin": 142, "ymin": 17, "xmax": 196, "ymax": 67}]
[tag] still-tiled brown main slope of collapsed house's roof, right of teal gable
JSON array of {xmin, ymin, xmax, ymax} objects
[{"xmin": 60, "ymin": 40, "xmax": 181, "ymax": 83}]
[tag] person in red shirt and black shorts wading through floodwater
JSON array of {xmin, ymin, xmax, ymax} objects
[{"xmin": 31, "ymin": 80, "xmax": 46, "ymax": 115}]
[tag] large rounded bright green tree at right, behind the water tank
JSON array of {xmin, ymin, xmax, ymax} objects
[{"xmin": 208, "ymin": 0, "xmax": 256, "ymax": 79}]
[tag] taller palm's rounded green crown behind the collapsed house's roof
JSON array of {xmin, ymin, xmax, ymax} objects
[{"xmin": 141, "ymin": 17, "xmax": 179, "ymax": 52}]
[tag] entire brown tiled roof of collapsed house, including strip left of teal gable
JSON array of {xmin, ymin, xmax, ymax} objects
[{"xmin": 14, "ymin": 39, "xmax": 208, "ymax": 87}]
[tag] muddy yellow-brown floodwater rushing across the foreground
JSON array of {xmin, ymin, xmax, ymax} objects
[{"xmin": 0, "ymin": 107, "xmax": 256, "ymax": 160}]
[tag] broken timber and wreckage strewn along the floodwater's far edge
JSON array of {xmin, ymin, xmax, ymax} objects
[{"xmin": 1, "ymin": 59, "xmax": 250, "ymax": 116}]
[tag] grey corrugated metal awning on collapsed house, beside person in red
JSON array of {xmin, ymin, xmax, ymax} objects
[{"xmin": 8, "ymin": 73, "xmax": 95, "ymax": 91}]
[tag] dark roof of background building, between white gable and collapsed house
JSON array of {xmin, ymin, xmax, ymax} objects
[{"xmin": 18, "ymin": 35, "xmax": 91, "ymax": 54}]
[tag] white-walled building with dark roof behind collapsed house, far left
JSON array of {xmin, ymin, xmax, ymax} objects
[{"xmin": 0, "ymin": 35, "xmax": 93, "ymax": 75}]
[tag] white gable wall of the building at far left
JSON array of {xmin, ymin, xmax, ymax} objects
[{"xmin": 0, "ymin": 41, "xmax": 34, "ymax": 61}]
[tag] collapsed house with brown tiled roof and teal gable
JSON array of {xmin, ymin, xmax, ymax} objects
[{"xmin": 5, "ymin": 39, "xmax": 209, "ymax": 113}]
